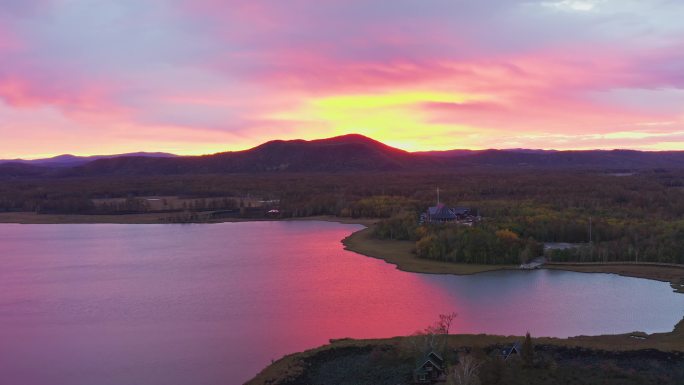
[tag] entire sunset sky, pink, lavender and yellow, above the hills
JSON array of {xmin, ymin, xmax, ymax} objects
[{"xmin": 0, "ymin": 0, "xmax": 684, "ymax": 159}]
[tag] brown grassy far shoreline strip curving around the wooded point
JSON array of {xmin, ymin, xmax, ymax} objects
[{"xmin": 0, "ymin": 212, "xmax": 684, "ymax": 293}]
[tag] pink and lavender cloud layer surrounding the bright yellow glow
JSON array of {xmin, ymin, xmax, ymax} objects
[{"xmin": 0, "ymin": 0, "xmax": 684, "ymax": 155}]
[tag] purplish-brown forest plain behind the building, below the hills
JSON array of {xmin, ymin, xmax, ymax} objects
[{"xmin": 0, "ymin": 169, "xmax": 684, "ymax": 218}]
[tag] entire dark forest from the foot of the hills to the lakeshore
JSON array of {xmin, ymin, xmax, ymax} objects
[{"xmin": 0, "ymin": 168, "xmax": 684, "ymax": 263}]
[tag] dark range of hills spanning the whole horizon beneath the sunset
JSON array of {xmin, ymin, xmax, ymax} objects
[{"xmin": 0, "ymin": 134, "xmax": 684, "ymax": 177}]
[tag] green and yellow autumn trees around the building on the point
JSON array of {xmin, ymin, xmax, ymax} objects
[{"xmin": 374, "ymin": 205, "xmax": 684, "ymax": 264}]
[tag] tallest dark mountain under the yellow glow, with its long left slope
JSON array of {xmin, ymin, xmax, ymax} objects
[{"xmin": 71, "ymin": 134, "xmax": 436, "ymax": 176}]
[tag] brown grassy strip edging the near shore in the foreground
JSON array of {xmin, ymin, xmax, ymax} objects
[{"xmin": 247, "ymin": 319, "xmax": 684, "ymax": 385}]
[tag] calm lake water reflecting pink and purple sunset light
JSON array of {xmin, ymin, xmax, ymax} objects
[{"xmin": 0, "ymin": 222, "xmax": 684, "ymax": 385}]
